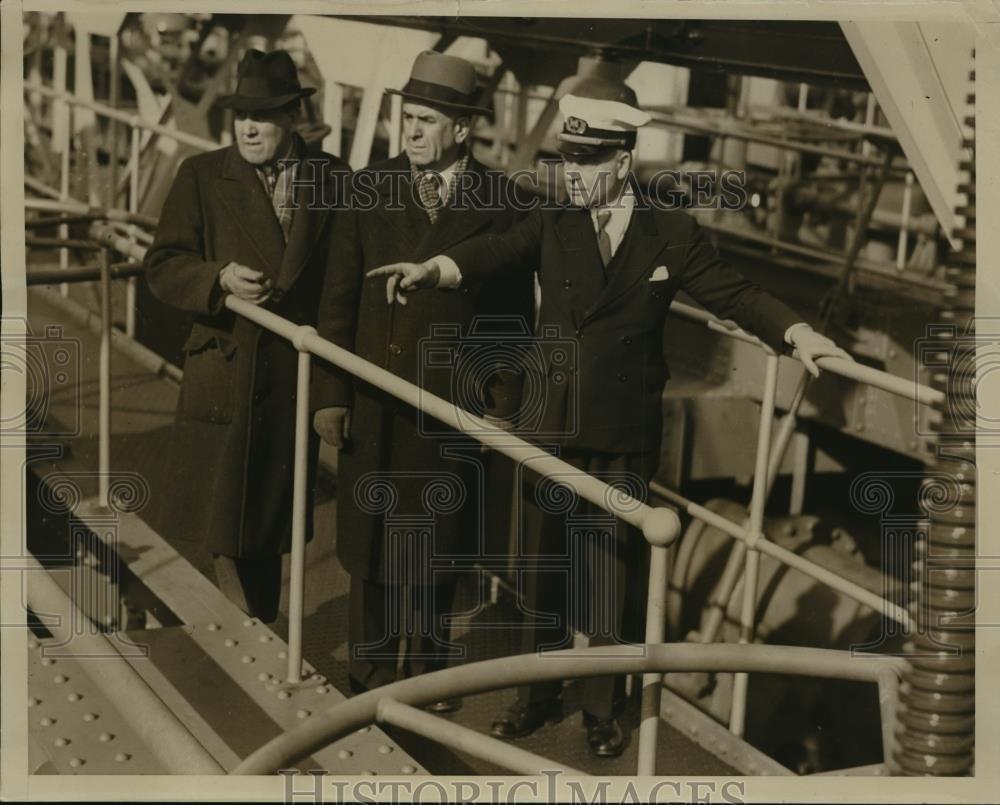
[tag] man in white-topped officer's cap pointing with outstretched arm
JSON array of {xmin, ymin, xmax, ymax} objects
[{"xmin": 369, "ymin": 70, "xmax": 848, "ymax": 756}]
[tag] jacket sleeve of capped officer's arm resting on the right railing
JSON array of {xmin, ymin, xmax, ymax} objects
[{"xmin": 681, "ymin": 218, "xmax": 803, "ymax": 354}]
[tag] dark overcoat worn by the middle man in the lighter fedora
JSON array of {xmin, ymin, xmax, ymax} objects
[{"xmin": 314, "ymin": 155, "xmax": 533, "ymax": 583}]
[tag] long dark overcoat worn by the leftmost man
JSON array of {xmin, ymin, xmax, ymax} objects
[{"xmin": 146, "ymin": 139, "xmax": 349, "ymax": 557}]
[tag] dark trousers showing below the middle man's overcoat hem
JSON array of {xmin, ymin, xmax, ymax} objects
[{"xmin": 347, "ymin": 576, "xmax": 456, "ymax": 692}]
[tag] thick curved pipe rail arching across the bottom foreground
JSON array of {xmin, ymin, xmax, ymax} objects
[{"xmin": 232, "ymin": 643, "xmax": 904, "ymax": 774}]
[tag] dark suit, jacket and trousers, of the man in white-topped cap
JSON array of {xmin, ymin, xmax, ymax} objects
[{"xmin": 442, "ymin": 196, "xmax": 798, "ymax": 718}]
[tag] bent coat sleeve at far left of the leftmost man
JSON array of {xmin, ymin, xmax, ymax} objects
[{"xmin": 145, "ymin": 159, "xmax": 228, "ymax": 314}]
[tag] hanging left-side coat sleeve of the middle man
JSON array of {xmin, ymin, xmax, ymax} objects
[{"xmin": 311, "ymin": 208, "xmax": 364, "ymax": 411}]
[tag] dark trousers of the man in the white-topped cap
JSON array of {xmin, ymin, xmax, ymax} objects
[{"xmin": 518, "ymin": 450, "xmax": 659, "ymax": 719}]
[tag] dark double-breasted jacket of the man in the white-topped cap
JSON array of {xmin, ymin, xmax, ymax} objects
[{"xmin": 448, "ymin": 203, "xmax": 801, "ymax": 455}]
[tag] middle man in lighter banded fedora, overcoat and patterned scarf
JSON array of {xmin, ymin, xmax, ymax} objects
[{"xmin": 314, "ymin": 51, "xmax": 532, "ymax": 710}]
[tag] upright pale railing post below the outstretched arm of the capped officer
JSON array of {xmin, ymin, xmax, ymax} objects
[{"xmin": 729, "ymin": 352, "xmax": 778, "ymax": 736}]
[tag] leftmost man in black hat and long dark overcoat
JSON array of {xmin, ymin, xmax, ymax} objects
[{"xmin": 146, "ymin": 50, "xmax": 353, "ymax": 621}]
